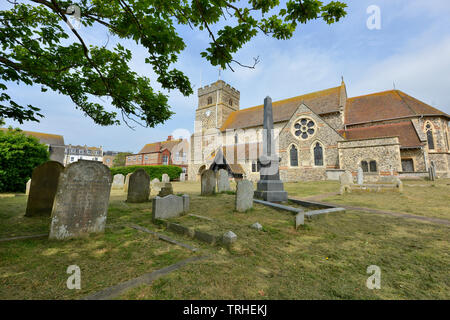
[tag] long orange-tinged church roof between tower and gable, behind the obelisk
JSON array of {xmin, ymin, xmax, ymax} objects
[{"xmin": 220, "ymin": 86, "xmax": 341, "ymax": 131}]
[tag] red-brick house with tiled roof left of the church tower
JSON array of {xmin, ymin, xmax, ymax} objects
[{"xmin": 125, "ymin": 136, "xmax": 189, "ymax": 172}]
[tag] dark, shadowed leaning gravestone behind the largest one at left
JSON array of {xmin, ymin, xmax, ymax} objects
[{"xmin": 25, "ymin": 161, "xmax": 64, "ymax": 217}]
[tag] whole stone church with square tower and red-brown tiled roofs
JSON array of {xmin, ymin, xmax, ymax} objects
[{"xmin": 188, "ymin": 80, "xmax": 450, "ymax": 181}]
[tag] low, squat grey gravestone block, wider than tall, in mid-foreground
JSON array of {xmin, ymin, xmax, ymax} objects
[{"xmin": 152, "ymin": 194, "xmax": 189, "ymax": 221}]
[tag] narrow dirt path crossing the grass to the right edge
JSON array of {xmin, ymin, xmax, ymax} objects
[{"xmin": 293, "ymin": 192, "xmax": 450, "ymax": 226}]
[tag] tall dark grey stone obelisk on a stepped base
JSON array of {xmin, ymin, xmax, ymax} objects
[{"xmin": 255, "ymin": 97, "xmax": 287, "ymax": 202}]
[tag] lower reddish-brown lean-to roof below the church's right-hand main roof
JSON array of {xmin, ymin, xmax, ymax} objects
[{"xmin": 339, "ymin": 120, "xmax": 422, "ymax": 148}]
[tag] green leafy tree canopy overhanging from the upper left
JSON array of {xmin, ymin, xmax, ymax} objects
[{"xmin": 0, "ymin": 0, "xmax": 346, "ymax": 127}]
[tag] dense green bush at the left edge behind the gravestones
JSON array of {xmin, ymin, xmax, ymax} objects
[{"xmin": 0, "ymin": 127, "xmax": 49, "ymax": 192}]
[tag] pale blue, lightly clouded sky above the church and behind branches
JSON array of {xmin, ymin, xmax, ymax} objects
[{"xmin": 0, "ymin": 0, "xmax": 450, "ymax": 152}]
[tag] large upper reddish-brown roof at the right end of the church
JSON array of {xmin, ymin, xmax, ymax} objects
[{"xmin": 345, "ymin": 90, "xmax": 450, "ymax": 125}]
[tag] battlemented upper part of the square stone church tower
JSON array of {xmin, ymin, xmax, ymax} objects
[{"xmin": 195, "ymin": 80, "xmax": 240, "ymax": 133}]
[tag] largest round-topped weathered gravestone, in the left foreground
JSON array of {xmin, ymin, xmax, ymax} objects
[{"xmin": 49, "ymin": 160, "xmax": 112, "ymax": 240}]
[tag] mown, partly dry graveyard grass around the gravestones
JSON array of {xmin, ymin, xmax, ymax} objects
[{"xmin": 0, "ymin": 179, "xmax": 450, "ymax": 299}]
